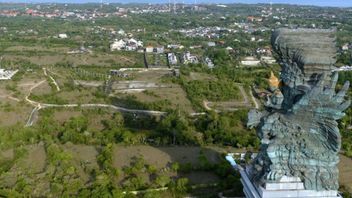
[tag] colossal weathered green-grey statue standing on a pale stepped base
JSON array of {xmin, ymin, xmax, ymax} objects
[{"xmin": 247, "ymin": 29, "xmax": 350, "ymax": 193}]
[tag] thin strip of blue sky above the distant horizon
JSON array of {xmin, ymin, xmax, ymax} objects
[{"xmin": 0, "ymin": 0, "xmax": 352, "ymax": 7}]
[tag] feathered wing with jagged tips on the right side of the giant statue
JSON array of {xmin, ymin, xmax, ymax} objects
[{"xmin": 292, "ymin": 72, "xmax": 351, "ymax": 152}]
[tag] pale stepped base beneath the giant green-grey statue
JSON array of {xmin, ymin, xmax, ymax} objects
[{"xmin": 240, "ymin": 170, "xmax": 342, "ymax": 198}]
